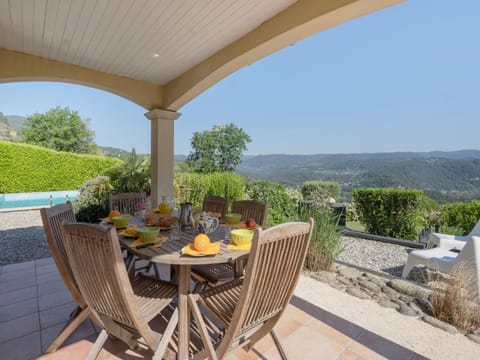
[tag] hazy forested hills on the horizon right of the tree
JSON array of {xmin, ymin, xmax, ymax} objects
[{"xmin": 237, "ymin": 150, "xmax": 480, "ymax": 202}]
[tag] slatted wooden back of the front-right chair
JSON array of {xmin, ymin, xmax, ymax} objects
[{"xmin": 217, "ymin": 219, "xmax": 313, "ymax": 358}]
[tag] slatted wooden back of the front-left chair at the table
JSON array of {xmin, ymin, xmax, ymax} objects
[{"xmin": 63, "ymin": 223, "xmax": 160, "ymax": 349}]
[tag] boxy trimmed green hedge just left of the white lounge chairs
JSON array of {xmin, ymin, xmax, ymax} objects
[{"xmin": 352, "ymin": 188, "xmax": 424, "ymax": 240}]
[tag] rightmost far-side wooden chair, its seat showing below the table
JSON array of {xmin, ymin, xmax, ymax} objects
[{"xmin": 192, "ymin": 200, "xmax": 268, "ymax": 290}]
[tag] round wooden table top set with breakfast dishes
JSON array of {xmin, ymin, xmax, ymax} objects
[{"xmin": 118, "ymin": 227, "xmax": 250, "ymax": 265}]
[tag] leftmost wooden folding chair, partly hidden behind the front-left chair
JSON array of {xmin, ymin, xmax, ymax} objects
[{"xmin": 40, "ymin": 203, "xmax": 100, "ymax": 353}]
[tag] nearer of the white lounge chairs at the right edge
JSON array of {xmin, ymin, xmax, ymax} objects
[{"xmin": 402, "ymin": 236, "xmax": 480, "ymax": 302}]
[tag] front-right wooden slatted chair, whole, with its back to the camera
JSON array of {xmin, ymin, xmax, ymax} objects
[{"xmin": 188, "ymin": 219, "xmax": 313, "ymax": 359}]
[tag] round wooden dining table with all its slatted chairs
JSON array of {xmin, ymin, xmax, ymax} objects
[{"xmin": 41, "ymin": 193, "xmax": 313, "ymax": 359}]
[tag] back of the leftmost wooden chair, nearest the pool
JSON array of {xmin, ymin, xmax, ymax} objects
[{"xmin": 40, "ymin": 203, "xmax": 86, "ymax": 308}]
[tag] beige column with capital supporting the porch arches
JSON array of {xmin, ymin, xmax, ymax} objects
[{"xmin": 145, "ymin": 109, "xmax": 181, "ymax": 207}]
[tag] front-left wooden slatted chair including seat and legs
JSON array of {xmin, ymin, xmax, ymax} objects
[{"xmin": 63, "ymin": 223, "xmax": 178, "ymax": 359}]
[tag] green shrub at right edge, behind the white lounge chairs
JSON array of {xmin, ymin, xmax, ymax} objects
[{"xmin": 442, "ymin": 200, "xmax": 480, "ymax": 235}]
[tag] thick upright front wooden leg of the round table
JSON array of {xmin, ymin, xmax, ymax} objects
[{"xmin": 177, "ymin": 265, "xmax": 191, "ymax": 360}]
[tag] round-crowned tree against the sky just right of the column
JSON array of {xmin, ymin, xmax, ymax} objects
[{"xmin": 186, "ymin": 124, "xmax": 252, "ymax": 173}]
